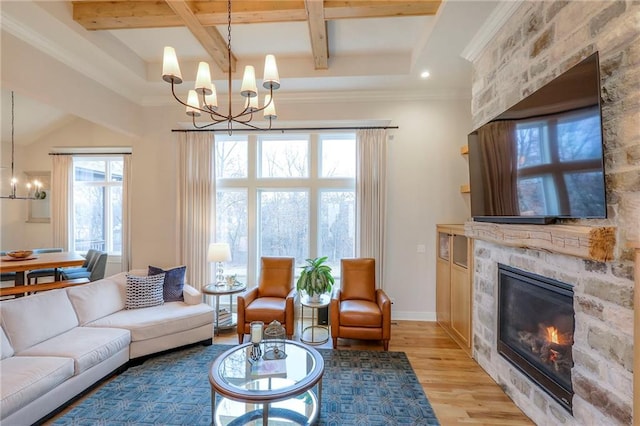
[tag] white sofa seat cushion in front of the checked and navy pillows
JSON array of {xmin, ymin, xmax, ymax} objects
[{"xmin": 87, "ymin": 302, "xmax": 213, "ymax": 342}]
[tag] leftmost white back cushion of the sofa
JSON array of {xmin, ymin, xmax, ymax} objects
[{"xmin": 0, "ymin": 289, "xmax": 78, "ymax": 353}]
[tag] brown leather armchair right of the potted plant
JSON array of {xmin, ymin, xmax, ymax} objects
[{"xmin": 329, "ymin": 258, "xmax": 391, "ymax": 351}]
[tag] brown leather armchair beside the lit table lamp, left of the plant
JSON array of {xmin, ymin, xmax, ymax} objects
[{"xmin": 238, "ymin": 257, "xmax": 296, "ymax": 343}]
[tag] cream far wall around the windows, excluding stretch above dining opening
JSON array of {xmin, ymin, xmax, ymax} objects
[{"xmin": 1, "ymin": 95, "xmax": 470, "ymax": 319}]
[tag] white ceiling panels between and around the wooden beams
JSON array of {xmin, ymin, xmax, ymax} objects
[{"xmin": 0, "ymin": 0, "xmax": 504, "ymax": 144}]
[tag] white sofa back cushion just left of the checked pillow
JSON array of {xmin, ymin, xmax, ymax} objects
[{"xmin": 66, "ymin": 278, "xmax": 125, "ymax": 325}]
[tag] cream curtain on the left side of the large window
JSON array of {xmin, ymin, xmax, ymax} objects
[{"xmin": 178, "ymin": 132, "xmax": 215, "ymax": 289}]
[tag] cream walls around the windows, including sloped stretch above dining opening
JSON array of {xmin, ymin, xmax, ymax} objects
[{"xmin": 0, "ymin": 26, "xmax": 471, "ymax": 319}]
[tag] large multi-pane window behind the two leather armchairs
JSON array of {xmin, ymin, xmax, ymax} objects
[{"xmin": 215, "ymin": 133, "xmax": 356, "ymax": 285}]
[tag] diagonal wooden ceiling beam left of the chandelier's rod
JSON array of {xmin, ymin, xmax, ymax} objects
[{"xmin": 167, "ymin": 0, "xmax": 236, "ymax": 72}]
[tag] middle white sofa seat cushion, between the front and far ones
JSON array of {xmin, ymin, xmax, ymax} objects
[{"xmin": 16, "ymin": 327, "xmax": 131, "ymax": 374}]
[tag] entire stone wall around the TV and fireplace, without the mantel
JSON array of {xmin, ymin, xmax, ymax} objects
[{"xmin": 472, "ymin": 0, "xmax": 640, "ymax": 425}]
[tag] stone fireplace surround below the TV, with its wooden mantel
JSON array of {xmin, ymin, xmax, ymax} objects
[{"xmin": 465, "ymin": 222, "xmax": 633, "ymax": 425}]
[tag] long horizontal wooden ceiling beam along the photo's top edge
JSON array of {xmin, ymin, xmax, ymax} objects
[{"xmin": 72, "ymin": 0, "xmax": 441, "ymax": 30}]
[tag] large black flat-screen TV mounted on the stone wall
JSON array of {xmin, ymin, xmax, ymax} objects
[{"xmin": 469, "ymin": 52, "xmax": 607, "ymax": 224}]
